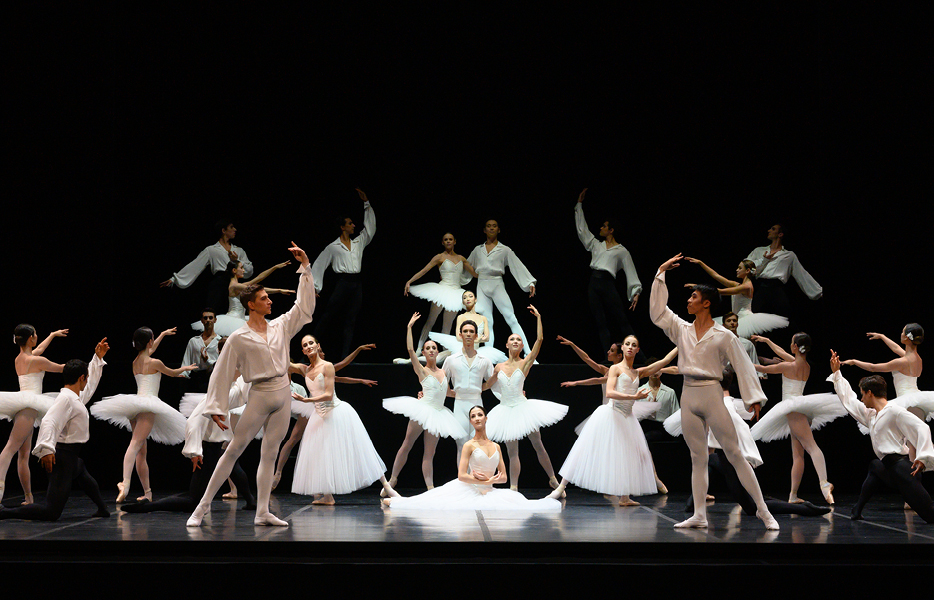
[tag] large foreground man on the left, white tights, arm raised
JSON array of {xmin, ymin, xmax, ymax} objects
[{"xmin": 187, "ymin": 242, "xmax": 315, "ymax": 527}]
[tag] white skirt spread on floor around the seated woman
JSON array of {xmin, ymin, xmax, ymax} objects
[{"xmin": 389, "ymin": 479, "xmax": 561, "ymax": 512}]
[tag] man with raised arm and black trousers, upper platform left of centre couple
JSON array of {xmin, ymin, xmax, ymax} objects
[{"xmin": 311, "ymin": 188, "xmax": 376, "ymax": 358}]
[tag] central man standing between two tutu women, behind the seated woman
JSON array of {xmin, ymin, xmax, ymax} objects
[{"xmin": 444, "ymin": 320, "xmax": 493, "ymax": 462}]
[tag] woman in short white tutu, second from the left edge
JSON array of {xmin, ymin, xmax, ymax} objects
[{"xmin": 91, "ymin": 327, "xmax": 198, "ymax": 502}]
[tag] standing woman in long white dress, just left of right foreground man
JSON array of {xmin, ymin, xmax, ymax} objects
[{"xmin": 549, "ymin": 335, "xmax": 678, "ymax": 506}]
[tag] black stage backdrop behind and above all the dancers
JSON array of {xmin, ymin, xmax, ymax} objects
[{"xmin": 0, "ymin": 7, "xmax": 934, "ymax": 494}]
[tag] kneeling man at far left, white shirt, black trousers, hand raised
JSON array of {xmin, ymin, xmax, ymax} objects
[{"xmin": 0, "ymin": 338, "xmax": 110, "ymax": 521}]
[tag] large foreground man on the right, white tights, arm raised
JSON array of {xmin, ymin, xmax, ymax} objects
[{"xmin": 649, "ymin": 254, "xmax": 778, "ymax": 530}]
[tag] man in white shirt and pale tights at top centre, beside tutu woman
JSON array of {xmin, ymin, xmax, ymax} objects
[{"xmin": 461, "ymin": 219, "xmax": 537, "ymax": 346}]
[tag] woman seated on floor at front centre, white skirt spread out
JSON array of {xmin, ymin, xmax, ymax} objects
[{"xmin": 382, "ymin": 406, "xmax": 561, "ymax": 512}]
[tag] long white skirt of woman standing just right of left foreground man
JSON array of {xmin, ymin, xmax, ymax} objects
[{"xmin": 292, "ymin": 402, "xmax": 386, "ymax": 495}]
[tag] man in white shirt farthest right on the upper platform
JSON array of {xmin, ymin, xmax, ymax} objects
[{"xmin": 746, "ymin": 224, "xmax": 824, "ymax": 317}]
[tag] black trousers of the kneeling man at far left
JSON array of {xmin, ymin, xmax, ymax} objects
[{"xmin": 0, "ymin": 444, "xmax": 107, "ymax": 521}]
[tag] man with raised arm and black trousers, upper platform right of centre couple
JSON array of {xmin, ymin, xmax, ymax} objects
[{"xmin": 574, "ymin": 188, "xmax": 642, "ymax": 348}]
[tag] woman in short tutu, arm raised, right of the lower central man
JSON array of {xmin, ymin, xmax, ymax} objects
[{"xmin": 483, "ymin": 306, "xmax": 568, "ymax": 490}]
